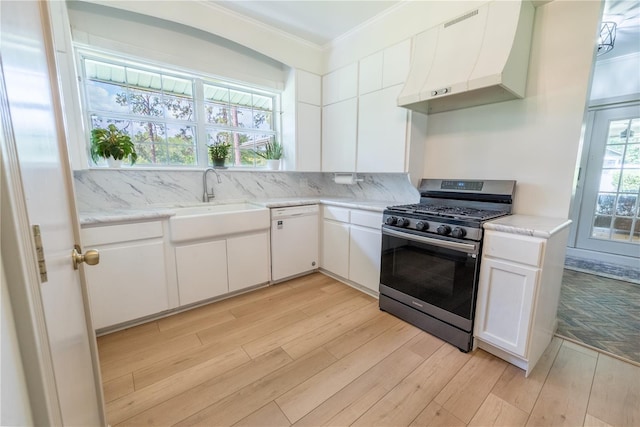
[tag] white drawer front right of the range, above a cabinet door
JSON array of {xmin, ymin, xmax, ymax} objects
[{"xmin": 483, "ymin": 230, "xmax": 544, "ymax": 266}]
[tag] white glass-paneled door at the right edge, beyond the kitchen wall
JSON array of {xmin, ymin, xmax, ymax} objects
[{"xmin": 577, "ymin": 106, "xmax": 640, "ymax": 257}]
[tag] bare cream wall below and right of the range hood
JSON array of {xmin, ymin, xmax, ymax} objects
[{"xmin": 424, "ymin": 1, "xmax": 600, "ymax": 218}]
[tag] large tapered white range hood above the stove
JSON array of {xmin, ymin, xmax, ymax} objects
[{"xmin": 398, "ymin": 0, "xmax": 534, "ymax": 114}]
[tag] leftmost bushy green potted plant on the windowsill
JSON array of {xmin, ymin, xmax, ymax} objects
[{"xmin": 91, "ymin": 124, "xmax": 138, "ymax": 167}]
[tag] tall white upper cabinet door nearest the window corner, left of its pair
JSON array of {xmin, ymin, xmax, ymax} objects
[{"xmin": 322, "ymin": 98, "xmax": 358, "ymax": 172}]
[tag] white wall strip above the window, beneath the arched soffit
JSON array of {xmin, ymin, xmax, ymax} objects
[{"xmin": 68, "ymin": 2, "xmax": 288, "ymax": 90}]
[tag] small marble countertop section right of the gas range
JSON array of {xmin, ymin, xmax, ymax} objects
[{"xmin": 484, "ymin": 214, "xmax": 571, "ymax": 239}]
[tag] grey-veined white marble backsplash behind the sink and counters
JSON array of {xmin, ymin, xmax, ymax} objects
[{"xmin": 74, "ymin": 169, "xmax": 420, "ymax": 212}]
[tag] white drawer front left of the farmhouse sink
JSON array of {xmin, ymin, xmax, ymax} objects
[{"xmin": 82, "ymin": 221, "xmax": 162, "ymax": 246}]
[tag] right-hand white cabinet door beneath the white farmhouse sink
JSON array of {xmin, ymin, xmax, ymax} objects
[{"xmin": 227, "ymin": 231, "xmax": 269, "ymax": 292}]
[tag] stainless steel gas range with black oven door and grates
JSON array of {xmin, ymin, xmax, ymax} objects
[{"xmin": 380, "ymin": 179, "xmax": 516, "ymax": 352}]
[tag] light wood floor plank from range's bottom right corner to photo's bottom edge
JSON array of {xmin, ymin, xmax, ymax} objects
[{"xmin": 353, "ymin": 344, "xmax": 471, "ymax": 427}]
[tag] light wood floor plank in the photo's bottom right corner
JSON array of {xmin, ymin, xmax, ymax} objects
[{"xmin": 587, "ymin": 354, "xmax": 640, "ymax": 426}]
